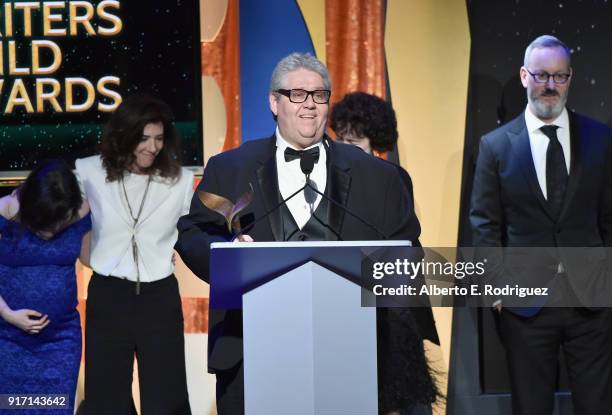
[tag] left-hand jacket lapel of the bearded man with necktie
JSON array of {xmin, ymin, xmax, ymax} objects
[{"xmin": 507, "ymin": 114, "xmax": 555, "ymax": 221}]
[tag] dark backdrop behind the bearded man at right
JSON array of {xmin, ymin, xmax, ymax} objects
[{"xmin": 459, "ymin": 0, "xmax": 612, "ymax": 400}]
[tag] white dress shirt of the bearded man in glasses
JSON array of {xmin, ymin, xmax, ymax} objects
[{"xmin": 525, "ymin": 106, "xmax": 571, "ymax": 199}]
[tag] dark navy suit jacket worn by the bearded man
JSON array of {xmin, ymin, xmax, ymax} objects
[{"xmin": 470, "ymin": 112, "xmax": 612, "ymax": 315}]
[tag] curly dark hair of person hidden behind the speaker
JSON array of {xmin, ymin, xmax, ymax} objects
[{"xmin": 331, "ymin": 92, "xmax": 398, "ymax": 152}]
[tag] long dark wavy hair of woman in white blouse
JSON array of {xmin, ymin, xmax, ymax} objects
[{"xmin": 100, "ymin": 94, "xmax": 181, "ymax": 182}]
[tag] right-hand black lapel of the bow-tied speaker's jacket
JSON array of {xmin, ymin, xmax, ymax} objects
[{"xmin": 324, "ymin": 136, "xmax": 351, "ymax": 239}]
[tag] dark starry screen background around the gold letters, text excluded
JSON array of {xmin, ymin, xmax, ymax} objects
[{"xmin": 0, "ymin": 0, "xmax": 202, "ymax": 176}]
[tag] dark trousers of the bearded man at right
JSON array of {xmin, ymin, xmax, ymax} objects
[{"xmin": 499, "ymin": 308, "xmax": 612, "ymax": 415}]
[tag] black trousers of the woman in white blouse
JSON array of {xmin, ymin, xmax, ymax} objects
[{"xmin": 85, "ymin": 273, "xmax": 191, "ymax": 415}]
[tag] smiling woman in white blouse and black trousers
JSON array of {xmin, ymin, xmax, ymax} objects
[{"xmin": 76, "ymin": 95, "xmax": 193, "ymax": 415}]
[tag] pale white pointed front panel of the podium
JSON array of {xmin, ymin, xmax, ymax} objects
[{"xmin": 243, "ymin": 262, "xmax": 378, "ymax": 415}]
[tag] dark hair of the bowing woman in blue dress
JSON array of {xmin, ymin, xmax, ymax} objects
[{"xmin": 17, "ymin": 160, "xmax": 83, "ymax": 233}]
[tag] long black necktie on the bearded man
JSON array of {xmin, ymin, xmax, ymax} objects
[{"xmin": 540, "ymin": 125, "xmax": 568, "ymax": 218}]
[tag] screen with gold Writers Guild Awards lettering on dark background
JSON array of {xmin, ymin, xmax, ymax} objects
[{"xmin": 0, "ymin": 0, "xmax": 202, "ymax": 177}]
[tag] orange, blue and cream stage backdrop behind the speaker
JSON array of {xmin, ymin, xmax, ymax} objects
[{"xmin": 196, "ymin": 0, "xmax": 470, "ymax": 414}]
